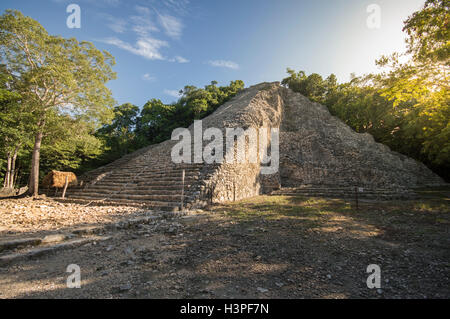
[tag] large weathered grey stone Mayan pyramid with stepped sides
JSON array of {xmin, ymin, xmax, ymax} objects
[{"xmin": 68, "ymin": 82, "xmax": 444, "ymax": 211}]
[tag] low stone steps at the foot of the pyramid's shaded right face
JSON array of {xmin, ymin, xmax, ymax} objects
[{"xmin": 271, "ymin": 186, "xmax": 417, "ymax": 200}]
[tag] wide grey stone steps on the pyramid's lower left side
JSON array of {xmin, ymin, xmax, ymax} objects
[{"xmin": 67, "ymin": 159, "xmax": 207, "ymax": 211}]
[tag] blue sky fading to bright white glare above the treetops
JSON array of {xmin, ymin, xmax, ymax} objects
[{"xmin": 0, "ymin": 0, "xmax": 425, "ymax": 107}]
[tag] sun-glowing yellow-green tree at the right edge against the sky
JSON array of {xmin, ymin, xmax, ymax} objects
[{"xmin": 375, "ymin": 0, "xmax": 450, "ymax": 174}]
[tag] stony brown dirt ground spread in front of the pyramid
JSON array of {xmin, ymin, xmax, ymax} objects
[{"xmin": 0, "ymin": 194, "xmax": 450, "ymax": 299}]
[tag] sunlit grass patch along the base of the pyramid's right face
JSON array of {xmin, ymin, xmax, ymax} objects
[{"xmin": 214, "ymin": 196, "xmax": 450, "ymax": 239}]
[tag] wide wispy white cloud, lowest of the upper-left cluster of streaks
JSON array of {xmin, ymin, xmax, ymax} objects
[{"xmin": 102, "ymin": 37, "xmax": 169, "ymax": 60}]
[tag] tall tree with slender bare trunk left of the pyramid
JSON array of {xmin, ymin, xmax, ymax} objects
[{"xmin": 0, "ymin": 10, "xmax": 115, "ymax": 196}]
